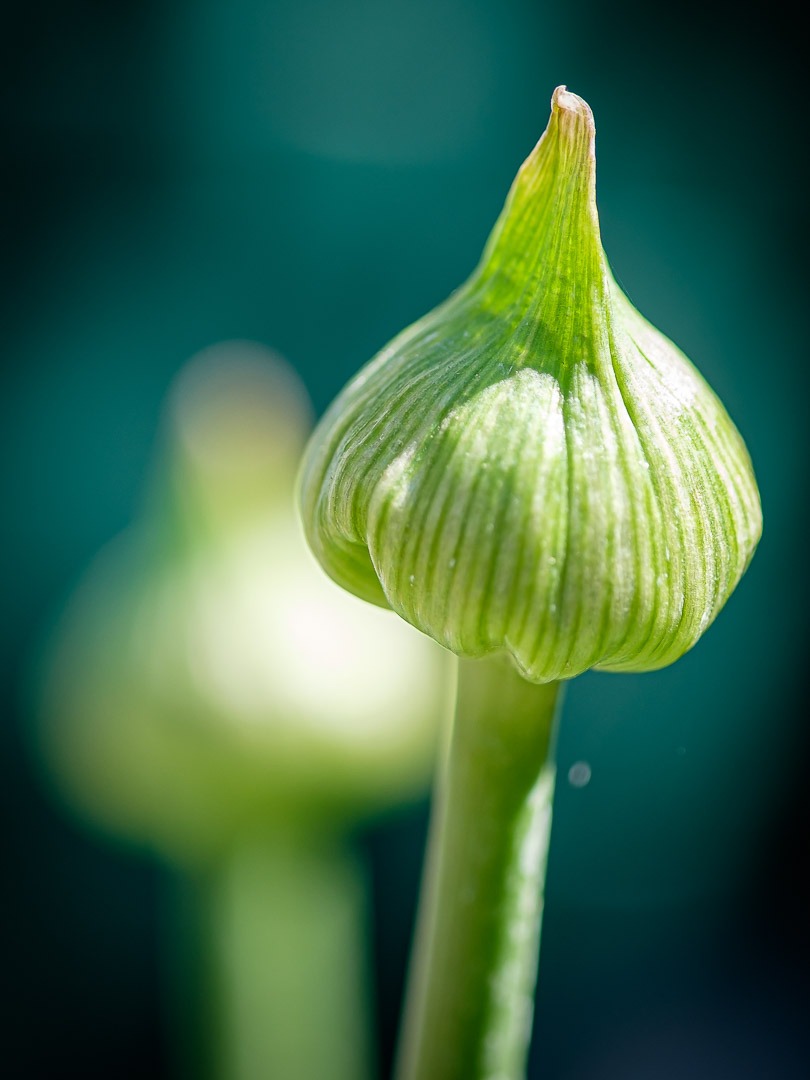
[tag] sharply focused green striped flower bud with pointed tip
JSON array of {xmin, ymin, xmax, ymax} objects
[{"xmin": 301, "ymin": 86, "xmax": 761, "ymax": 683}]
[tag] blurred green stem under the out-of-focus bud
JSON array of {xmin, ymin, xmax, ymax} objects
[{"xmin": 169, "ymin": 837, "xmax": 374, "ymax": 1080}]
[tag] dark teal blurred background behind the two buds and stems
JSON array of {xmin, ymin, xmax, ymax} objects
[{"xmin": 0, "ymin": 0, "xmax": 810, "ymax": 1080}]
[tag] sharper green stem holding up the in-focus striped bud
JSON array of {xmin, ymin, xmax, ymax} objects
[{"xmin": 396, "ymin": 659, "xmax": 559, "ymax": 1080}]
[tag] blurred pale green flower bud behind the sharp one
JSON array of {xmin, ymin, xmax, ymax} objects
[{"xmin": 39, "ymin": 342, "xmax": 450, "ymax": 861}]
